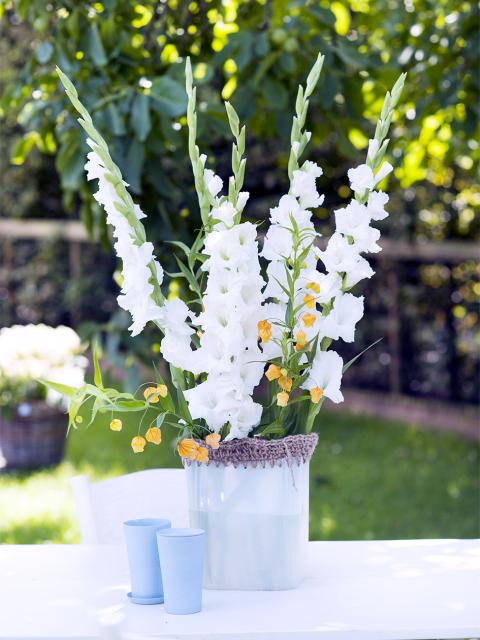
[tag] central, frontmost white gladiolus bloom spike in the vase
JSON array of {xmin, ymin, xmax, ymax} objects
[{"xmin": 184, "ymin": 222, "xmax": 265, "ymax": 437}]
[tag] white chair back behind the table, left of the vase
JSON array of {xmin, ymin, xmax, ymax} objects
[{"xmin": 71, "ymin": 469, "xmax": 188, "ymax": 544}]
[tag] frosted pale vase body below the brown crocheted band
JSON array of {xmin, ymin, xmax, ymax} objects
[{"xmin": 185, "ymin": 436, "xmax": 316, "ymax": 590}]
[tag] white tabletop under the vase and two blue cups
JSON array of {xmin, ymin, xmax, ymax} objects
[{"xmin": 0, "ymin": 540, "xmax": 480, "ymax": 640}]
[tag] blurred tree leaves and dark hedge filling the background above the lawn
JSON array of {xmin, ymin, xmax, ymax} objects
[{"xmin": 0, "ymin": 0, "xmax": 480, "ymax": 402}]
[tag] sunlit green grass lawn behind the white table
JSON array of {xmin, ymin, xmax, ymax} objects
[{"xmin": 0, "ymin": 412, "xmax": 479, "ymax": 543}]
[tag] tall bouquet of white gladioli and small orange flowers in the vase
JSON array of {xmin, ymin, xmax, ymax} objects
[{"xmin": 50, "ymin": 55, "xmax": 405, "ymax": 462}]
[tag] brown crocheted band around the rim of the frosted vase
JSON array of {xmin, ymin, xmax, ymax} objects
[{"xmin": 182, "ymin": 433, "xmax": 318, "ymax": 467}]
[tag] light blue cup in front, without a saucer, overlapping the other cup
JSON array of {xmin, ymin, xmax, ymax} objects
[{"xmin": 157, "ymin": 529, "xmax": 205, "ymax": 615}]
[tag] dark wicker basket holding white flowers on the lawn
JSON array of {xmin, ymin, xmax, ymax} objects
[{"xmin": 0, "ymin": 401, "xmax": 67, "ymax": 470}]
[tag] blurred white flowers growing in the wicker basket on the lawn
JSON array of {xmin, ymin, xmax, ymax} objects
[{"xmin": 0, "ymin": 324, "xmax": 87, "ymax": 416}]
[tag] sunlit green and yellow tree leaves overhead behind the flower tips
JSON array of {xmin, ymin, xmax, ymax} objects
[{"xmin": 0, "ymin": 0, "xmax": 479, "ymax": 245}]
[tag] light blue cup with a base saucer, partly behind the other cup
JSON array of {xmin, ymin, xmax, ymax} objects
[{"xmin": 123, "ymin": 518, "xmax": 172, "ymax": 604}]
